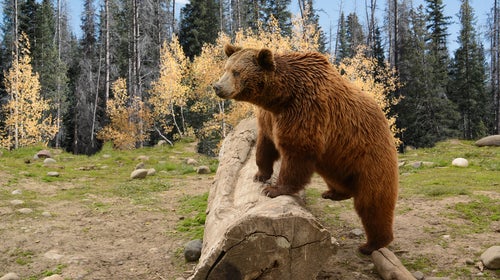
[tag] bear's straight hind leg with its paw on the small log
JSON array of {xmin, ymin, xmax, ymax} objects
[{"xmin": 354, "ymin": 189, "xmax": 395, "ymax": 255}]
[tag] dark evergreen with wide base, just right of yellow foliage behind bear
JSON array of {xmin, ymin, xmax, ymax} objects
[{"xmin": 394, "ymin": 6, "xmax": 457, "ymax": 147}]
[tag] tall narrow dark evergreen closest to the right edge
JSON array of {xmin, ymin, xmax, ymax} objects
[{"xmin": 449, "ymin": 0, "xmax": 492, "ymax": 139}]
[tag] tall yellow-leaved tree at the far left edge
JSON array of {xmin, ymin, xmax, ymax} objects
[{"xmin": 0, "ymin": 33, "xmax": 57, "ymax": 149}]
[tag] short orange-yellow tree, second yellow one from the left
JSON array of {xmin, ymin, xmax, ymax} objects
[{"xmin": 97, "ymin": 78, "xmax": 152, "ymax": 150}]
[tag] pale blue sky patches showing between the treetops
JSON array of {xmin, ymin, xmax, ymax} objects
[{"xmin": 62, "ymin": 0, "xmax": 494, "ymax": 51}]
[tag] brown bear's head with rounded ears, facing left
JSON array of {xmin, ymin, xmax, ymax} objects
[{"xmin": 214, "ymin": 44, "xmax": 276, "ymax": 104}]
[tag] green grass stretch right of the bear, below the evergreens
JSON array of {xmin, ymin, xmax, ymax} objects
[{"xmin": 399, "ymin": 140, "xmax": 500, "ymax": 198}]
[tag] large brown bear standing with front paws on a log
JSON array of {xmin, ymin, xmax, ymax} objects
[{"xmin": 214, "ymin": 45, "xmax": 398, "ymax": 254}]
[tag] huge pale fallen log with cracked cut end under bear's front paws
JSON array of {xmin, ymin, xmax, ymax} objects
[{"xmin": 190, "ymin": 119, "xmax": 336, "ymax": 280}]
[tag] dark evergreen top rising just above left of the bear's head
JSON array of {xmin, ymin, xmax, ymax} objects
[{"xmin": 179, "ymin": 0, "xmax": 220, "ymax": 59}]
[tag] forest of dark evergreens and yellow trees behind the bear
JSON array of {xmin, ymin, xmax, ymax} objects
[{"xmin": 0, "ymin": 0, "xmax": 500, "ymax": 155}]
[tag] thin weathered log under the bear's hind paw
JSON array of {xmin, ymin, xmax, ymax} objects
[{"xmin": 372, "ymin": 248, "xmax": 415, "ymax": 280}]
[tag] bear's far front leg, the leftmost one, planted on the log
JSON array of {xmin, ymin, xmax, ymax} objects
[{"xmin": 254, "ymin": 133, "xmax": 280, "ymax": 182}]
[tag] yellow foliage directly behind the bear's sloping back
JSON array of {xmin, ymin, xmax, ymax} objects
[{"xmin": 337, "ymin": 46, "xmax": 401, "ymax": 146}]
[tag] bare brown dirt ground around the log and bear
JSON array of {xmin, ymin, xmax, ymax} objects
[{"xmin": 0, "ymin": 171, "xmax": 500, "ymax": 280}]
